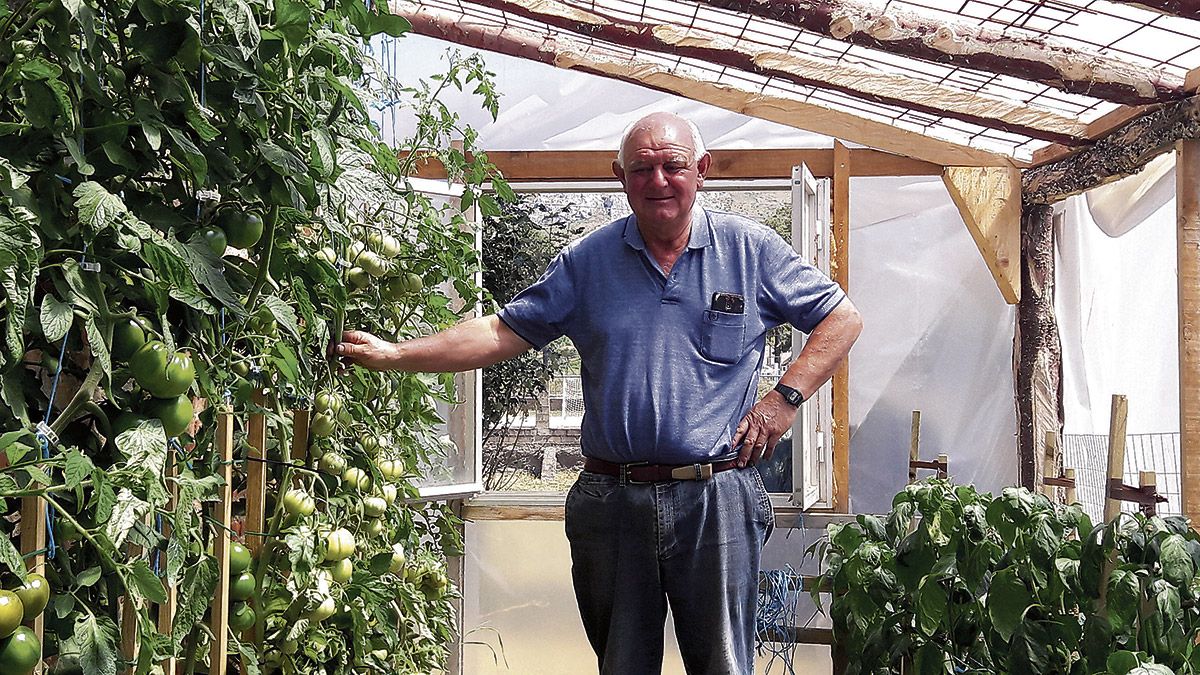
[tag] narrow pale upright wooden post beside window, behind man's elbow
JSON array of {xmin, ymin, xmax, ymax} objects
[{"xmin": 829, "ymin": 141, "xmax": 851, "ymax": 513}]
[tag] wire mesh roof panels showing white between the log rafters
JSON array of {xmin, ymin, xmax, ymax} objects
[{"xmin": 400, "ymin": 0, "xmax": 1200, "ymax": 160}]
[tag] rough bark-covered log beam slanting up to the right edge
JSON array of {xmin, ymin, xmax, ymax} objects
[{"xmin": 1021, "ymin": 96, "xmax": 1200, "ymax": 204}]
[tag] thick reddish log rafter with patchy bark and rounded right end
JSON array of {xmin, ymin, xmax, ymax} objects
[{"xmin": 696, "ymin": 0, "xmax": 1186, "ymax": 104}]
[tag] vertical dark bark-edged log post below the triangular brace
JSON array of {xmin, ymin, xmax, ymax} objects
[{"xmin": 1013, "ymin": 205, "xmax": 1062, "ymax": 490}]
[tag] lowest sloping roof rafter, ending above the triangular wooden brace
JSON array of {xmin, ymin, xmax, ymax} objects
[{"xmin": 392, "ymin": 4, "xmax": 1024, "ymax": 166}]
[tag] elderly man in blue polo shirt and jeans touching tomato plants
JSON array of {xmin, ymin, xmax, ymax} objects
[{"xmin": 337, "ymin": 113, "xmax": 862, "ymax": 675}]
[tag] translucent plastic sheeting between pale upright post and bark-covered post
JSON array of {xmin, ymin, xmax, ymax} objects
[{"xmin": 850, "ymin": 178, "xmax": 1016, "ymax": 513}]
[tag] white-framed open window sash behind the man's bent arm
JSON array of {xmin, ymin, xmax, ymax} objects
[{"xmin": 792, "ymin": 165, "xmax": 833, "ymax": 509}]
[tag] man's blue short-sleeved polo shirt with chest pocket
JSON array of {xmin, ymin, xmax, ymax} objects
[{"xmin": 499, "ymin": 208, "xmax": 845, "ymax": 464}]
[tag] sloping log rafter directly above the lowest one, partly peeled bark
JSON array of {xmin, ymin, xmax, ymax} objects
[{"xmin": 463, "ymin": 0, "xmax": 1087, "ymax": 145}]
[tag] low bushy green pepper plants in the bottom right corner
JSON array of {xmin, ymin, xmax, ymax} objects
[{"xmin": 814, "ymin": 479, "xmax": 1200, "ymax": 675}]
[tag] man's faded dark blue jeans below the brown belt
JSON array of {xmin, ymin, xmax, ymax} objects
[{"xmin": 566, "ymin": 467, "xmax": 774, "ymax": 675}]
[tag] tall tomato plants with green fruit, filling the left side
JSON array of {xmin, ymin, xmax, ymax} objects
[{"xmin": 0, "ymin": 0, "xmax": 506, "ymax": 675}]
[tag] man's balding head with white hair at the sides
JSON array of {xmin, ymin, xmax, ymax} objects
[{"xmin": 612, "ymin": 119, "xmax": 710, "ymax": 227}]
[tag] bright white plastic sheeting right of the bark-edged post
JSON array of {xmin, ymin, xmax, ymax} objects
[{"xmin": 1055, "ymin": 154, "xmax": 1180, "ymax": 434}]
